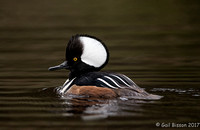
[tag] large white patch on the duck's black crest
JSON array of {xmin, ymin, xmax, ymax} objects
[{"xmin": 80, "ymin": 36, "xmax": 108, "ymax": 67}]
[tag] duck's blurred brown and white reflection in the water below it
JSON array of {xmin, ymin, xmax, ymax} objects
[{"xmin": 61, "ymin": 95, "xmax": 149, "ymax": 120}]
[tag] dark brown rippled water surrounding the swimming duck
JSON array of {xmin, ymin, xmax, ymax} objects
[{"xmin": 0, "ymin": 0, "xmax": 200, "ymax": 129}]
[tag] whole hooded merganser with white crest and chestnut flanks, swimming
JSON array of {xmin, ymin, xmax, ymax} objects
[{"xmin": 49, "ymin": 35, "xmax": 160, "ymax": 99}]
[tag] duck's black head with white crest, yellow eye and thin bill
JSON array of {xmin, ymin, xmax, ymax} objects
[{"xmin": 49, "ymin": 35, "xmax": 109, "ymax": 79}]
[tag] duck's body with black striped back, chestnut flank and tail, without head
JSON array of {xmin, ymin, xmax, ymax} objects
[{"xmin": 62, "ymin": 72, "xmax": 159, "ymax": 99}]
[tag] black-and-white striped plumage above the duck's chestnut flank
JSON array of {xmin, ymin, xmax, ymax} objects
[{"xmin": 59, "ymin": 72, "xmax": 144, "ymax": 93}]
